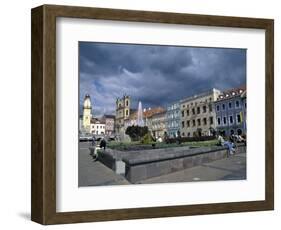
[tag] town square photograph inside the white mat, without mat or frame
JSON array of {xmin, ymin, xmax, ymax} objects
[{"xmin": 78, "ymin": 41, "xmax": 247, "ymax": 187}]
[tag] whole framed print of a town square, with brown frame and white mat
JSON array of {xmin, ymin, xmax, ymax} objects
[{"xmin": 31, "ymin": 5, "xmax": 274, "ymax": 224}]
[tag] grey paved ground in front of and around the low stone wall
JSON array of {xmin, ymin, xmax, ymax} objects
[{"xmin": 79, "ymin": 142, "xmax": 246, "ymax": 187}]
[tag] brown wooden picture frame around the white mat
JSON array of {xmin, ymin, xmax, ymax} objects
[{"xmin": 31, "ymin": 5, "xmax": 274, "ymax": 224}]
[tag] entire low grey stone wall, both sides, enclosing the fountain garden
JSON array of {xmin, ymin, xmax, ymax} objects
[{"xmin": 94, "ymin": 145, "xmax": 246, "ymax": 183}]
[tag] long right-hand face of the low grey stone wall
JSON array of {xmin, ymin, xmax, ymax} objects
[{"xmin": 122, "ymin": 145, "xmax": 246, "ymax": 183}]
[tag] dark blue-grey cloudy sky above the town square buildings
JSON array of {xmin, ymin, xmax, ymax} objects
[{"xmin": 79, "ymin": 42, "xmax": 246, "ymax": 116}]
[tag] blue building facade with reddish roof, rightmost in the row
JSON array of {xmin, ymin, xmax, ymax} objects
[{"xmin": 215, "ymin": 88, "xmax": 247, "ymax": 136}]
